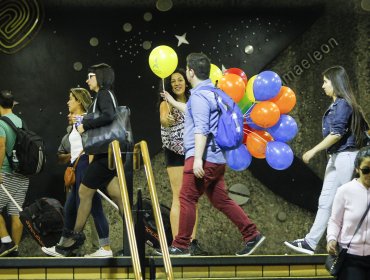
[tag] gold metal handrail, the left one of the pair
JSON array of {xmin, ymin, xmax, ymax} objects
[{"xmin": 108, "ymin": 140, "xmax": 143, "ymax": 280}]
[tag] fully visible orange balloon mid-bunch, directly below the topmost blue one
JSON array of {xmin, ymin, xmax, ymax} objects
[{"xmin": 250, "ymin": 101, "xmax": 280, "ymax": 128}]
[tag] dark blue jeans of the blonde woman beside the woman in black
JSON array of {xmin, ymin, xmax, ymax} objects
[{"xmin": 63, "ymin": 155, "xmax": 109, "ymax": 246}]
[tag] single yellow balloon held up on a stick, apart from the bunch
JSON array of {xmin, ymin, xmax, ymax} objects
[{"xmin": 149, "ymin": 45, "xmax": 178, "ymax": 79}]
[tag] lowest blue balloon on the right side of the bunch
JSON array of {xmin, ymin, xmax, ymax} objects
[{"xmin": 266, "ymin": 141, "xmax": 294, "ymax": 170}]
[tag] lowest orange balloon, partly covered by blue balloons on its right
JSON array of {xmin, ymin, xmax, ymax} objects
[{"xmin": 247, "ymin": 130, "xmax": 274, "ymax": 158}]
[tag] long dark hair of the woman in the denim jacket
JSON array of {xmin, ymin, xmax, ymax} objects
[{"xmin": 322, "ymin": 66, "xmax": 369, "ymax": 148}]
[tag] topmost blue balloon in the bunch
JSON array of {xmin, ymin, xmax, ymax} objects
[{"xmin": 253, "ymin": 71, "xmax": 282, "ymax": 101}]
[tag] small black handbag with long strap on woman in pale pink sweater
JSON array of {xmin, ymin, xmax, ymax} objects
[{"xmin": 325, "ymin": 201, "xmax": 370, "ymax": 276}]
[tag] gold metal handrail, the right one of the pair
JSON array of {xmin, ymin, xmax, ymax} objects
[{"xmin": 134, "ymin": 141, "xmax": 174, "ymax": 280}]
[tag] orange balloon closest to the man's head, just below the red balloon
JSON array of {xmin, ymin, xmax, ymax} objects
[{"xmin": 217, "ymin": 74, "xmax": 245, "ymax": 103}]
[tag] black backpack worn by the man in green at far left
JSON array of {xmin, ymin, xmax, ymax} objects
[{"xmin": 0, "ymin": 117, "xmax": 46, "ymax": 176}]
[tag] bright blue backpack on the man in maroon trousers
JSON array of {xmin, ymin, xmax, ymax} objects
[{"xmin": 200, "ymin": 86, "xmax": 243, "ymax": 151}]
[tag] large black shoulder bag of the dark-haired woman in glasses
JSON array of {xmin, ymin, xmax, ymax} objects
[{"xmin": 81, "ymin": 91, "xmax": 134, "ymax": 155}]
